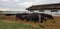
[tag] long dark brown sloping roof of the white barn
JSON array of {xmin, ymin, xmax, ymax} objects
[{"xmin": 26, "ymin": 3, "xmax": 60, "ymax": 10}]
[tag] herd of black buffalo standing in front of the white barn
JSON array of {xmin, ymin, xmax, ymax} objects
[{"xmin": 6, "ymin": 13, "xmax": 54, "ymax": 23}]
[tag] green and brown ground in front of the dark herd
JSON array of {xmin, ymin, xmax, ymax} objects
[{"xmin": 0, "ymin": 16, "xmax": 60, "ymax": 29}]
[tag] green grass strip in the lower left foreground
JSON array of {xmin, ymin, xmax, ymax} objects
[{"xmin": 0, "ymin": 21, "xmax": 39, "ymax": 29}]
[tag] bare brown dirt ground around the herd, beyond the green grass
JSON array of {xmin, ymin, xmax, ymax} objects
[{"xmin": 1, "ymin": 15, "xmax": 60, "ymax": 29}]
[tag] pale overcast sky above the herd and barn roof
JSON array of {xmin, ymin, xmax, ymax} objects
[{"xmin": 0, "ymin": 0, "xmax": 60, "ymax": 11}]
